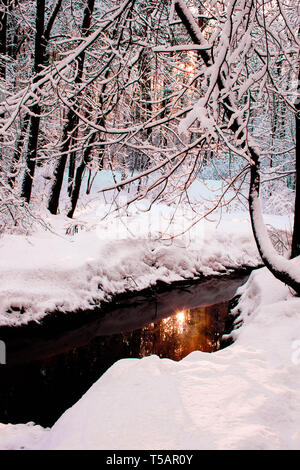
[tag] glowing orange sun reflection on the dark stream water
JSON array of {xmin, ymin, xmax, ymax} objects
[{"xmin": 124, "ymin": 302, "xmax": 228, "ymax": 361}]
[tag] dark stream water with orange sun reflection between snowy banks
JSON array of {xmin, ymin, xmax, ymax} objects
[{"xmin": 0, "ymin": 274, "xmax": 248, "ymax": 426}]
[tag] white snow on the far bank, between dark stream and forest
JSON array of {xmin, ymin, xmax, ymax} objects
[{"xmin": 0, "ymin": 172, "xmax": 268, "ymax": 325}]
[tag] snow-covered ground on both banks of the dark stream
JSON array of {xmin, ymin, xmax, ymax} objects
[{"xmin": 0, "ymin": 173, "xmax": 300, "ymax": 450}]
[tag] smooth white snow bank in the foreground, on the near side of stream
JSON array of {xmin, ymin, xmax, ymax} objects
[{"xmin": 0, "ymin": 268, "xmax": 300, "ymax": 450}]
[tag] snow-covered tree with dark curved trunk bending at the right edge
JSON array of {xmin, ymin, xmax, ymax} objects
[{"xmin": 159, "ymin": 0, "xmax": 300, "ymax": 294}]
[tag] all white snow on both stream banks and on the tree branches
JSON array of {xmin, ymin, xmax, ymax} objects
[{"xmin": 0, "ymin": 0, "xmax": 300, "ymax": 450}]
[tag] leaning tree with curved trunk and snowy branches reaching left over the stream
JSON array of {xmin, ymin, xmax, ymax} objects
[{"xmin": 98, "ymin": 0, "xmax": 300, "ymax": 294}]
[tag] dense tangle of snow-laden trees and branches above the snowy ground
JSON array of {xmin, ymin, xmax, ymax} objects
[{"xmin": 0, "ymin": 0, "xmax": 300, "ymax": 291}]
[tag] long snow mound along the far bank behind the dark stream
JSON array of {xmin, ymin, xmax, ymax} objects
[{"xmin": 0, "ymin": 210, "xmax": 259, "ymax": 325}]
